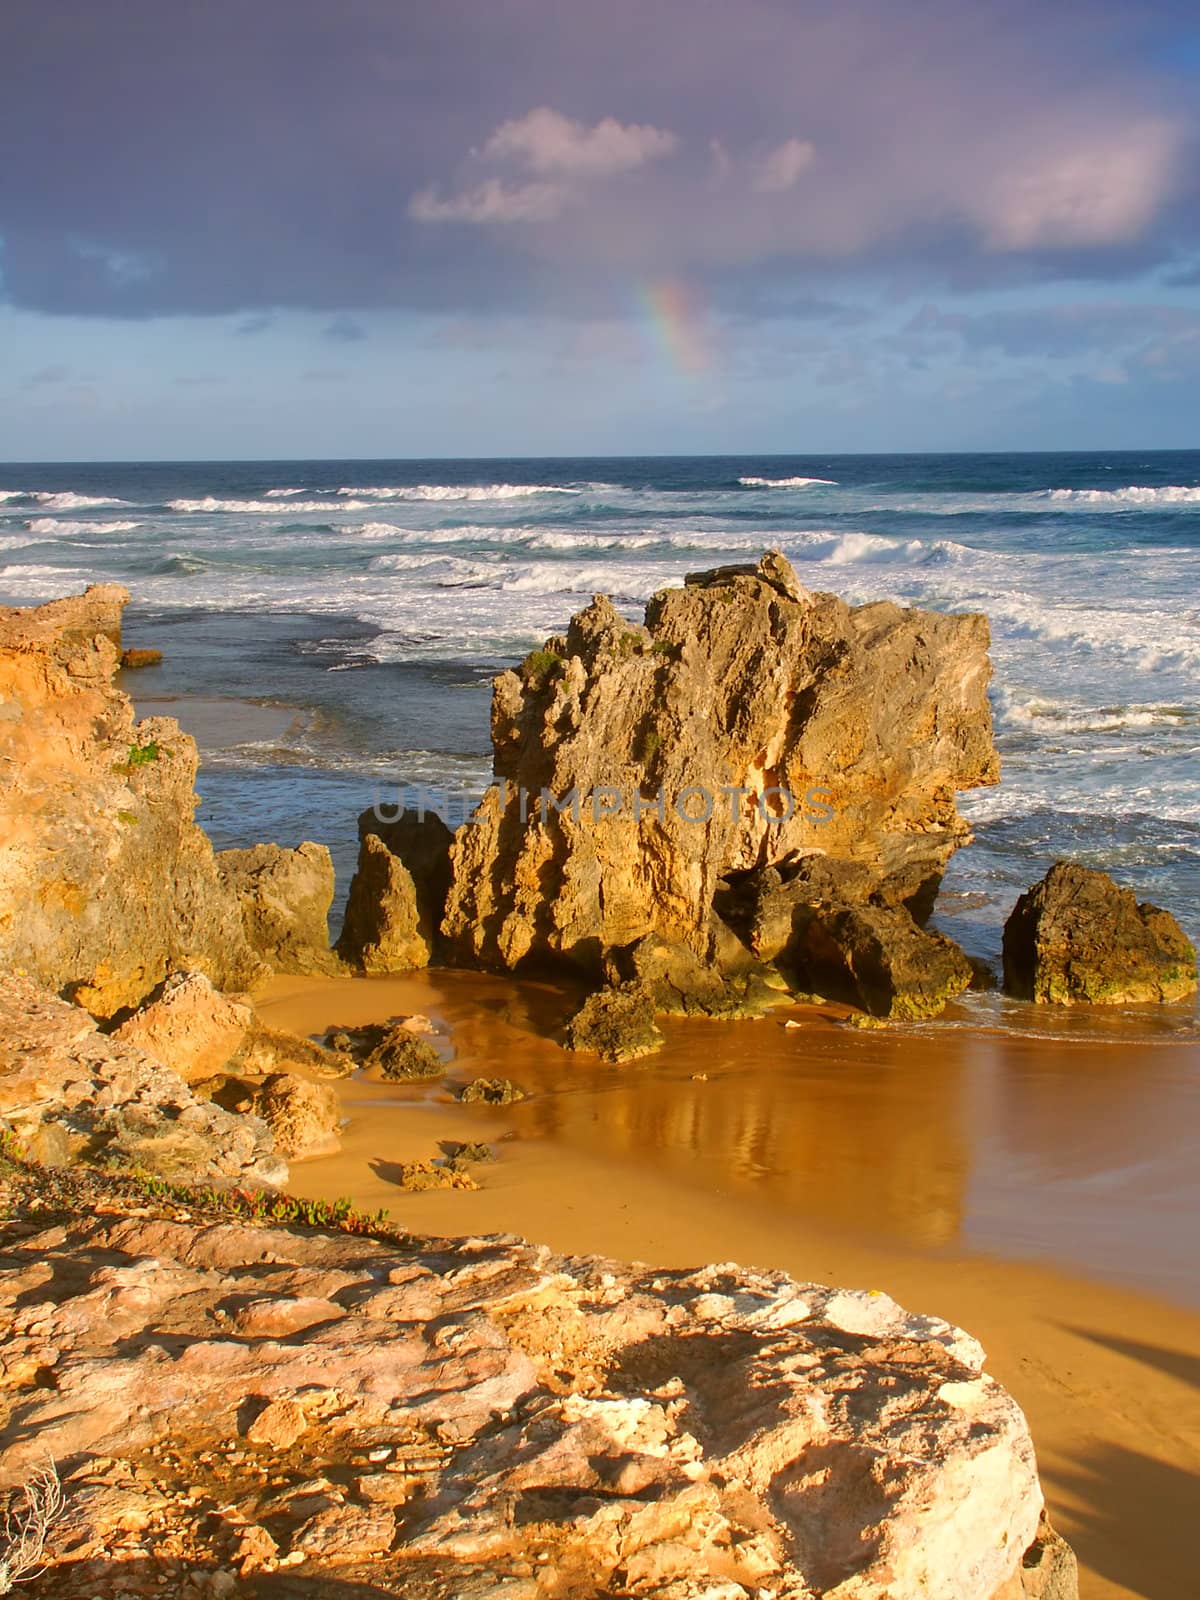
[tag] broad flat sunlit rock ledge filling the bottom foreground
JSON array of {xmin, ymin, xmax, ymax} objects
[{"xmin": 0, "ymin": 1205, "xmax": 1074, "ymax": 1600}]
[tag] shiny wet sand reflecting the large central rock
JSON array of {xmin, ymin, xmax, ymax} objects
[{"xmin": 267, "ymin": 971, "xmax": 1200, "ymax": 1301}]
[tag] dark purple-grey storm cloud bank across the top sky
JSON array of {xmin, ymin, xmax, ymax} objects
[{"xmin": 0, "ymin": 0, "xmax": 1197, "ymax": 318}]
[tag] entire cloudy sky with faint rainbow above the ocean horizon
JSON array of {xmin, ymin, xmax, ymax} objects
[{"xmin": 0, "ymin": 0, "xmax": 1200, "ymax": 461}]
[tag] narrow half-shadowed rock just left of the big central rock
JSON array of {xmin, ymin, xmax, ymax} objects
[{"xmin": 338, "ymin": 811, "xmax": 451, "ymax": 973}]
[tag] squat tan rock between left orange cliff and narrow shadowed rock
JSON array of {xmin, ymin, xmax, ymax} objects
[{"xmin": 216, "ymin": 842, "xmax": 338, "ymax": 973}]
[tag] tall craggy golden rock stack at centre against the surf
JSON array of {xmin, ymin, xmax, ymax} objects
[{"xmin": 443, "ymin": 554, "xmax": 998, "ymax": 968}]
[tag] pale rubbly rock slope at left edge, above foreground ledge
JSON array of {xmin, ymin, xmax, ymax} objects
[{"xmin": 0, "ymin": 974, "xmax": 288, "ymax": 1187}]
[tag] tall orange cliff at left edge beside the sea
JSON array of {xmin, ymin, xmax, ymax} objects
[{"xmin": 0, "ymin": 586, "xmax": 264, "ymax": 1016}]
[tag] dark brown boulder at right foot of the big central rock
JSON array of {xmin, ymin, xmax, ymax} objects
[{"xmin": 790, "ymin": 906, "xmax": 973, "ymax": 1021}]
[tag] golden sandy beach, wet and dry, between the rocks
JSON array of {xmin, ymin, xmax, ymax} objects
[{"xmin": 259, "ymin": 973, "xmax": 1200, "ymax": 1600}]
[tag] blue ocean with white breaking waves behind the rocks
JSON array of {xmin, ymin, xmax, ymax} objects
[{"xmin": 0, "ymin": 451, "xmax": 1200, "ymax": 1024}]
